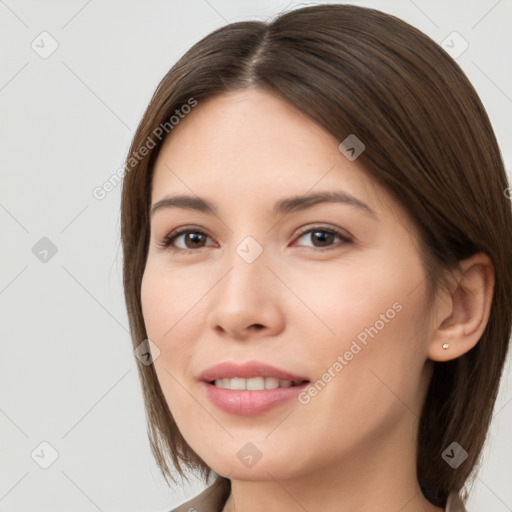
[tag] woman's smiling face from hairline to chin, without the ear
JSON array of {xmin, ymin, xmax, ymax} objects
[{"xmin": 141, "ymin": 89, "xmax": 431, "ymax": 480}]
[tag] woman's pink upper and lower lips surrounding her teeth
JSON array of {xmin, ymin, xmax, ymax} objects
[{"xmin": 200, "ymin": 361, "xmax": 310, "ymax": 416}]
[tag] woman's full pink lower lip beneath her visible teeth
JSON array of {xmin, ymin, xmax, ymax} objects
[{"xmin": 201, "ymin": 382, "xmax": 309, "ymax": 416}]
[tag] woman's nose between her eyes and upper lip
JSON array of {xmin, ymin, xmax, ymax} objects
[{"xmin": 209, "ymin": 247, "xmax": 286, "ymax": 341}]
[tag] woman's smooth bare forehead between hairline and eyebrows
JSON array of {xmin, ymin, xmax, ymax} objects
[{"xmin": 152, "ymin": 89, "xmax": 392, "ymax": 222}]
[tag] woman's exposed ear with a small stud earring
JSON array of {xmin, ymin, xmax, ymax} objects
[{"xmin": 427, "ymin": 252, "xmax": 495, "ymax": 361}]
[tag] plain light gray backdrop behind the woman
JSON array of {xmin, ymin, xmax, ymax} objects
[{"xmin": 0, "ymin": 0, "xmax": 512, "ymax": 512}]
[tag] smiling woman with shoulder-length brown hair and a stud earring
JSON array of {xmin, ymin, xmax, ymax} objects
[{"xmin": 122, "ymin": 5, "xmax": 512, "ymax": 512}]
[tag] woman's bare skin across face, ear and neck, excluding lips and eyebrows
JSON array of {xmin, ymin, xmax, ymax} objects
[{"xmin": 141, "ymin": 89, "xmax": 494, "ymax": 512}]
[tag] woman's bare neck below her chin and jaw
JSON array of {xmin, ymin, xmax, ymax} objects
[{"xmin": 223, "ymin": 416, "xmax": 443, "ymax": 512}]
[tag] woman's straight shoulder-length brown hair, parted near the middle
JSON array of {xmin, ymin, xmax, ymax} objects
[{"xmin": 121, "ymin": 5, "xmax": 512, "ymax": 507}]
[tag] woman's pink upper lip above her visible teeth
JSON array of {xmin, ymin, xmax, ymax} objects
[{"xmin": 199, "ymin": 361, "xmax": 308, "ymax": 384}]
